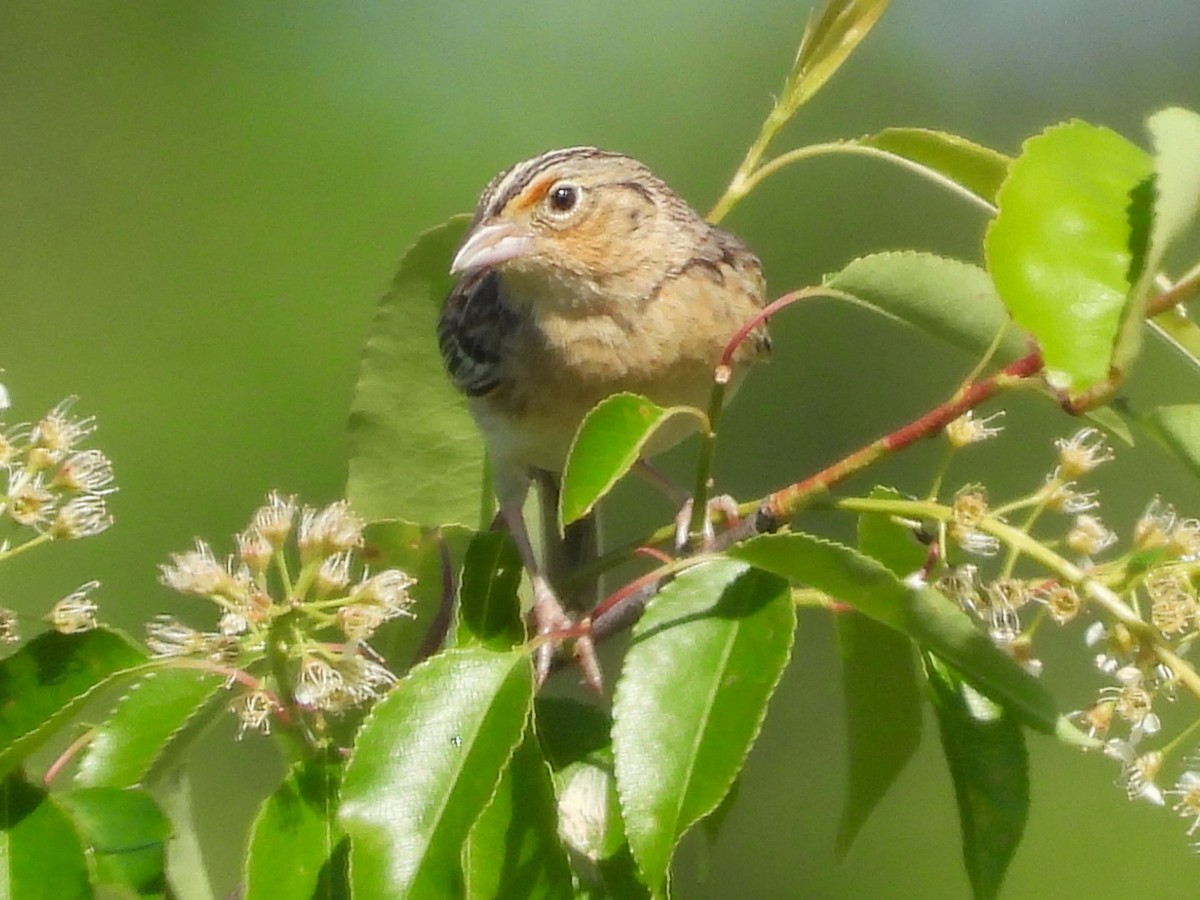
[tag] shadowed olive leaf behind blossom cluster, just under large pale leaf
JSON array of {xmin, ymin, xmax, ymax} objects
[{"xmin": 362, "ymin": 521, "xmax": 474, "ymax": 672}]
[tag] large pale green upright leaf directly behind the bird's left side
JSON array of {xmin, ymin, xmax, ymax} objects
[{"xmin": 346, "ymin": 216, "xmax": 484, "ymax": 524}]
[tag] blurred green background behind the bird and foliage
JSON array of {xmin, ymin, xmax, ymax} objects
[{"xmin": 0, "ymin": 0, "xmax": 1200, "ymax": 899}]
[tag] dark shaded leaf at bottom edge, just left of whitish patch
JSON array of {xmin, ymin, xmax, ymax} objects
[{"xmin": 463, "ymin": 731, "xmax": 571, "ymax": 900}]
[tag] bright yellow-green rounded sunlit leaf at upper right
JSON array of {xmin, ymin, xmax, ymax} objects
[{"xmin": 984, "ymin": 121, "xmax": 1151, "ymax": 395}]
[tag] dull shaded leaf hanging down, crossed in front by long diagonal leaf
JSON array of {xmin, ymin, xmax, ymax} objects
[{"xmin": 834, "ymin": 487, "xmax": 926, "ymax": 856}]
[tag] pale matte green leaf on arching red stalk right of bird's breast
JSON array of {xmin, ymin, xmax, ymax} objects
[{"xmin": 824, "ymin": 251, "xmax": 1030, "ymax": 360}]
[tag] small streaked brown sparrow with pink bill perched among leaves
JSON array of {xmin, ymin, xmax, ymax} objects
[{"xmin": 437, "ymin": 146, "xmax": 770, "ymax": 684}]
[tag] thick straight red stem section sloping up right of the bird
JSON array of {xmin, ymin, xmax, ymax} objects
[{"xmin": 758, "ymin": 350, "xmax": 1042, "ymax": 523}]
